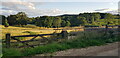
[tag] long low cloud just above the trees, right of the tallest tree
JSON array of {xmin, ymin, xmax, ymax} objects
[{"xmin": 27, "ymin": 9, "xmax": 64, "ymax": 16}]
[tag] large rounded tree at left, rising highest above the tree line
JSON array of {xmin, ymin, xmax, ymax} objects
[{"xmin": 7, "ymin": 12, "xmax": 28, "ymax": 26}]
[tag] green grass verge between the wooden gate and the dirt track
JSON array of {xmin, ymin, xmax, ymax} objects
[{"xmin": 3, "ymin": 31, "xmax": 120, "ymax": 56}]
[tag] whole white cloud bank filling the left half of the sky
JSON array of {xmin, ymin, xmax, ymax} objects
[{"xmin": 0, "ymin": 0, "xmax": 64, "ymax": 16}]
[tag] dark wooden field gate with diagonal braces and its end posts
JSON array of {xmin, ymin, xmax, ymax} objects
[{"xmin": 4, "ymin": 31, "xmax": 76, "ymax": 48}]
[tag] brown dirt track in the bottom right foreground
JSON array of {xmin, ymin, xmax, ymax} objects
[{"xmin": 36, "ymin": 42, "xmax": 118, "ymax": 56}]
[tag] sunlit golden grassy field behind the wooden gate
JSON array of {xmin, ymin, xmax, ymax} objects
[{"xmin": 0, "ymin": 25, "xmax": 83, "ymax": 39}]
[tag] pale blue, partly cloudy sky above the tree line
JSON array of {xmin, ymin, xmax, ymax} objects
[{"xmin": 0, "ymin": 0, "xmax": 119, "ymax": 17}]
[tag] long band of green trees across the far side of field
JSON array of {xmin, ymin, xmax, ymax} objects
[{"xmin": 0, "ymin": 12, "xmax": 120, "ymax": 28}]
